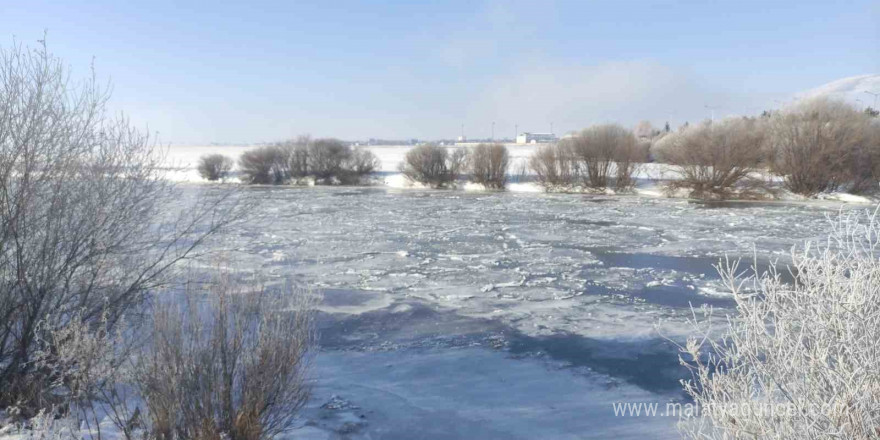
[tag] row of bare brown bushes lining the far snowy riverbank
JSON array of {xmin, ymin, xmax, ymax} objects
[{"xmin": 198, "ymin": 98, "xmax": 880, "ymax": 199}]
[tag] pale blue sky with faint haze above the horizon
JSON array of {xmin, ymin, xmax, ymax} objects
[{"xmin": 0, "ymin": 0, "xmax": 880, "ymax": 143}]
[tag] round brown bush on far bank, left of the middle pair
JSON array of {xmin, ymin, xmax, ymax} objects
[{"xmin": 400, "ymin": 144, "xmax": 467, "ymax": 188}]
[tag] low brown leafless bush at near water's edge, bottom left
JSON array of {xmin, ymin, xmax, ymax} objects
[{"xmin": 135, "ymin": 274, "xmax": 314, "ymax": 440}]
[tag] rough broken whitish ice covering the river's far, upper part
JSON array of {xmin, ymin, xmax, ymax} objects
[{"xmin": 179, "ymin": 186, "xmax": 852, "ymax": 336}]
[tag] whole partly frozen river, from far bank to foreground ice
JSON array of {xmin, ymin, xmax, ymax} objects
[{"xmin": 187, "ymin": 184, "xmax": 852, "ymax": 439}]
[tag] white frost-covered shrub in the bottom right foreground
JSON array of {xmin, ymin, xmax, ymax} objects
[{"xmin": 682, "ymin": 213, "xmax": 880, "ymax": 439}]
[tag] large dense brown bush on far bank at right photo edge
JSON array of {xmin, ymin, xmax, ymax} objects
[{"xmin": 768, "ymin": 99, "xmax": 880, "ymax": 196}]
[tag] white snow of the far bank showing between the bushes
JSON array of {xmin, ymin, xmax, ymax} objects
[{"xmin": 165, "ymin": 144, "xmax": 880, "ymax": 205}]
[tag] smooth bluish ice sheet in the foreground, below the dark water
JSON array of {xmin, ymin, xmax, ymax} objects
[{"xmin": 295, "ymin": 349, "xmax": 678, "ymax": 439}]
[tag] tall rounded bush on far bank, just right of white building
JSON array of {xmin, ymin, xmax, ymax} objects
[{"xmin": 566, "ymin": 124, "xmax": 644, "ymax": 189}]
